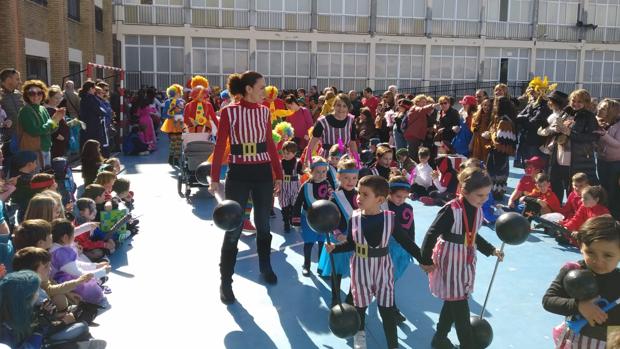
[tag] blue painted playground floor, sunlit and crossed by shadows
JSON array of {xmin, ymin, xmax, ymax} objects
[{"xmin": 88, "ymin": 140, "xmax": 580, "ymax": 349}]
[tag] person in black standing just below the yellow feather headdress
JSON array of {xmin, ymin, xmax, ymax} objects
[{"xmin": 517, "ymin": 89, "xmax": 551, "ymax": 161}]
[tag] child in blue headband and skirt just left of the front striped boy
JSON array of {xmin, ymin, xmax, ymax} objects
[{"xmin": 319, "ymin": 159, "xmax": 358, "ymax": 307}]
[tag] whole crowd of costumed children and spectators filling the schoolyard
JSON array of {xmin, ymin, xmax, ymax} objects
[{"xmin": 0, "ymin": 64, "xmax": 620, "ymax": 348}]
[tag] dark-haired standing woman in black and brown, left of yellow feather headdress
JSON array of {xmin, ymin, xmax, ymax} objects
[{"xmin": 482, "ymin": 97, "xmax": 517, "ymax": 200}]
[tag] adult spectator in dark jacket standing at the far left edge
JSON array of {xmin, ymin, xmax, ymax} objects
[{"xmin": 0, "ymin": 68, "xmax": 24, "ymax": 164}]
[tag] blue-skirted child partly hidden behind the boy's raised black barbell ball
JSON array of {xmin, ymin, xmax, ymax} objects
[{"xmin": 293, "ymin": 156, "xmax": 332, "ymax": 276}]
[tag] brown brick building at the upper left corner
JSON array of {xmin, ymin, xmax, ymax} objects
[{"xmin": 0, "ymin": 0, "xmax": 113, "ymax": 84}]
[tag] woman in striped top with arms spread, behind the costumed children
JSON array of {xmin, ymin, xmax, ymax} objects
[{"xmin": 306, "ymin": 93, "xmax": 358, "ymax": 165}]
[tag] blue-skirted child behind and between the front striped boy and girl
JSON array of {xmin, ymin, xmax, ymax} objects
[{"xmin": 387, "ymin": 176, "xmax": 415, "ymax": 323}]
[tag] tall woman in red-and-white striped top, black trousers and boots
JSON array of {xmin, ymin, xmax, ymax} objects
[{"xmin": 209, "ymin": 71, "xmax": 283, "ymax": 304}]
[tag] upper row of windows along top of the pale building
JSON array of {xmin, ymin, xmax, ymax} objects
[{"xmin": 118, "ymin": 0, "xmax": 620, "ymax": 27}]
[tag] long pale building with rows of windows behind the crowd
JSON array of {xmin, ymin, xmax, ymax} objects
[{"xmin": 113, "ymin": 0, "xmax": 620, "ymax": 97}]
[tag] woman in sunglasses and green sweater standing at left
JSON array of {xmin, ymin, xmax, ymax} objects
[{"xmin": 17, "ymin": 80, "xmax": 66, "ymax": 168}]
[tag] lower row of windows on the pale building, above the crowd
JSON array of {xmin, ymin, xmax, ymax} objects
[{"xmin": 125, "ymin": 35, "xmax": 620, "ymax": 88}]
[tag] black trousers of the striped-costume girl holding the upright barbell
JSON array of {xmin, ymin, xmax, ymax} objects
[{"xmin": 435, "ymin": 299, "xmax": 474, "ymax": 349}]
